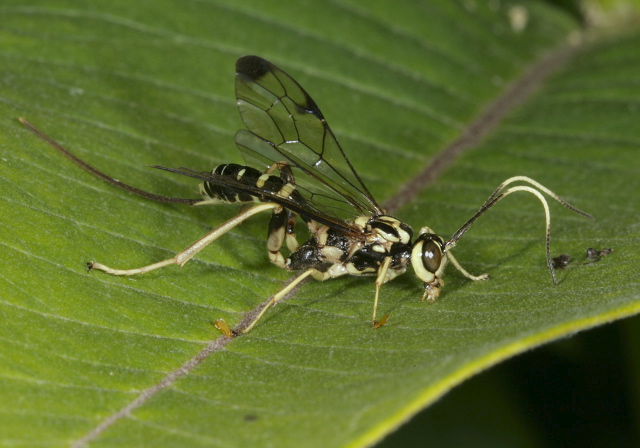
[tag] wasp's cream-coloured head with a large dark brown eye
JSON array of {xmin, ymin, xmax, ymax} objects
[{"xmin": 411, "ymin": 227, "xmax": 447, "ymax": 283}]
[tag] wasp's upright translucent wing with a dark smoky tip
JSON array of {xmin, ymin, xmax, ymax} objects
[{"xmin": 236, "ymin": 56, "xmax": 384, "ymax": 218}]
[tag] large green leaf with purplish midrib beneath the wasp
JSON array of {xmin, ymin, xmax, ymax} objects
[{"xmin": 0, "ymin": 0, "xmax": 640, "ymax": 447}]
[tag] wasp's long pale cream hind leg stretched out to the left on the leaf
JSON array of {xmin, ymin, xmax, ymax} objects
[{"xmin": 88, "ymin": 202, "xmax": 281, "ymax": 275}]
